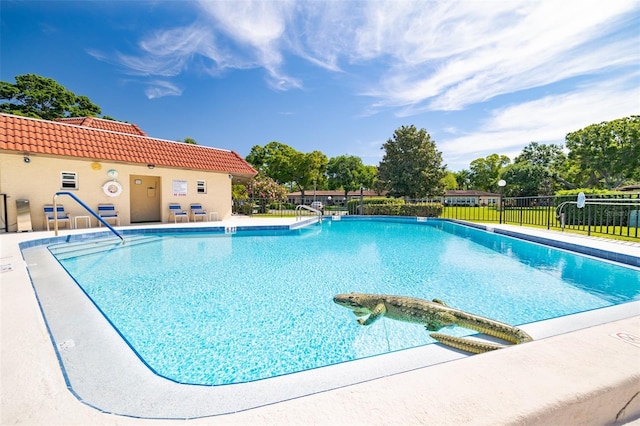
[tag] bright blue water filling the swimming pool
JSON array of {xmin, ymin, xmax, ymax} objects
[{"xmin": 52, "ymin": 220, "xmax": 640, "ymax": 385}]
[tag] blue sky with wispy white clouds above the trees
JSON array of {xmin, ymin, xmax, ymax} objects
[{"xmin": 0, "ymin": 0, "xmax": 640, "ymax": 171}]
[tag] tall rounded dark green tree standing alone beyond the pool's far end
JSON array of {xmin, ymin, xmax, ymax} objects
[{"xmin": 378, "ymin": 125, "xmax": 445, "ymax": 198}]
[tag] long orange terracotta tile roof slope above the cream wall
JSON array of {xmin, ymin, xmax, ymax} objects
[{"xmin": 0, "ymin": 114, "xmax": 257, "ymax": 177}]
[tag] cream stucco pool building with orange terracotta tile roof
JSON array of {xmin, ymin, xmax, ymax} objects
[{"xmin": 0, "ymin": 114, "xmax": 257, "ymax": 231}]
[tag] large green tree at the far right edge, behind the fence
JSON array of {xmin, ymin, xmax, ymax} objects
[{"xmin": 566, "ymin": 115, "xmax": 640, "ymax": 189}]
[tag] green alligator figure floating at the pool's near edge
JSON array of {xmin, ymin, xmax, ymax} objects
[{"xmin": 333, "ymin": 293, "xmax": 533, "ymax": 354}]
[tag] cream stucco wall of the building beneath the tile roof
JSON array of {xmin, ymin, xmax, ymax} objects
[{"xmin": 0, "ymin": 151, "xmax": 231, "ymax": 232}]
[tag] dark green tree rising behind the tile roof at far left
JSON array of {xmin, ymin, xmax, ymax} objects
[{"xmin": 0, "ymin": 74, "xmax": 101, "ymax": 120}]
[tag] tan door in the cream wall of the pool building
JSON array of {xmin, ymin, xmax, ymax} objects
[{"xmin": 129, "ymin": 175, "xmax": 162, "ymax": 223}]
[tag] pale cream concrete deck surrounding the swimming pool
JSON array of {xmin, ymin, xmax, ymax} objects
[{"xmin": 0, "ymin": 219, "xmax": 640, "ymax": 425}]
